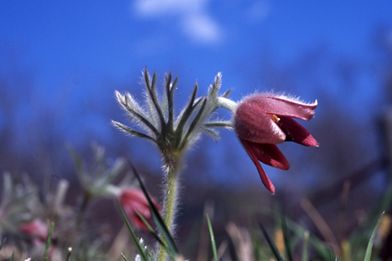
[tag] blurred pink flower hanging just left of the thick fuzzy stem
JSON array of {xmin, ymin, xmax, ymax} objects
[{"xmin": 119, "ymin": 188, "xmax": 155, "ymax": 229}]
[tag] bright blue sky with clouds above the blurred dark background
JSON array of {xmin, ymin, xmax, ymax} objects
[{"xmin": 0, "ymin": 0, "xmax": 392, "ymax": 88}]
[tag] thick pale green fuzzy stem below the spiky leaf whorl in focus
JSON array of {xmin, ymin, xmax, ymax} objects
[{"xmin": 158, "ymin": 153, "xmax": 180, "ymax": 261}]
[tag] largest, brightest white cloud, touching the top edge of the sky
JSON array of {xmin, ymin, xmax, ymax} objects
[{"xmin": 134, "ymin": 0, "xmax": 223, "ymax": 44}]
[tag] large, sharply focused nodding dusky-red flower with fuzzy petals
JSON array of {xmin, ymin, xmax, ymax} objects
[{"xmin": 234, "ymin": 93, "xmax": 318, "ymax": 193}]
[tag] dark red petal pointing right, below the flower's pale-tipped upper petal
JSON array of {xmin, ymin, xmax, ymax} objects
[{"xmin": 278, "ymin": 117, "xmax": 319, "ymax": 147}]
